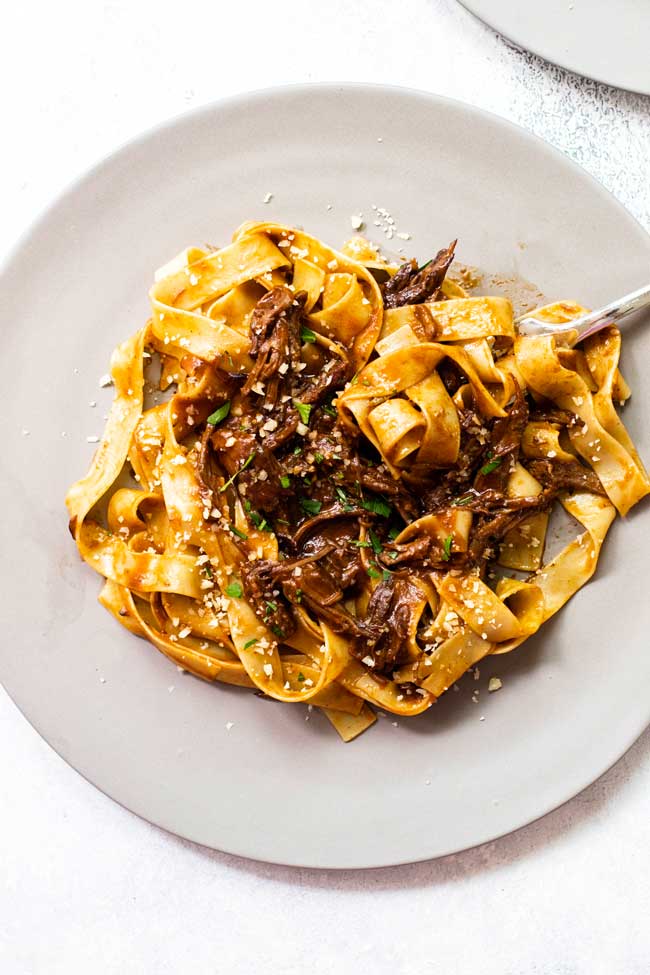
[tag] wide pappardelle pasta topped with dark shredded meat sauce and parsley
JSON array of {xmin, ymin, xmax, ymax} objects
[{"xmin": 66, "ymin": 223, "xmax": 650, "ymax": 741}]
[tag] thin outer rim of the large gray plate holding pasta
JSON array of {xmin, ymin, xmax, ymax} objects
[{"xmin": 0, "ymin": 82, "xmax": 650, "ymax": 871}]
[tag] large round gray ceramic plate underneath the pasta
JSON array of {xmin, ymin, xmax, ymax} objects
[{"xmin": 0, "ymin": 86, "xmax": 650, "ymax": 867}]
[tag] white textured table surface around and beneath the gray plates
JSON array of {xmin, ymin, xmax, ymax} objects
[{"xmin": 0, "ymin": 0, "xmax": 650, "ymax": 975}]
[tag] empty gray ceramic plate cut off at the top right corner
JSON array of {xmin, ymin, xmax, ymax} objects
[{"xmin": 461, "ymin": 0, "xmax": 650, "ymax": 95}]
